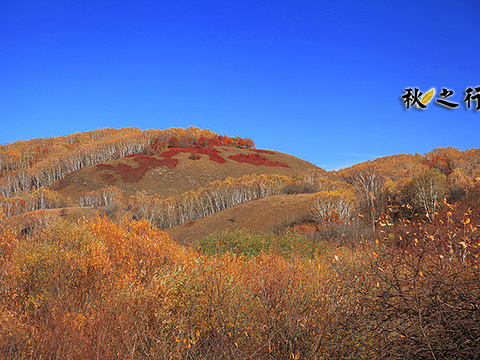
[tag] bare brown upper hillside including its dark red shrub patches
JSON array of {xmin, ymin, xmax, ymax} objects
[{"xmin": 54, "ymin": 146, "xmax": 318, "ymax": 199}]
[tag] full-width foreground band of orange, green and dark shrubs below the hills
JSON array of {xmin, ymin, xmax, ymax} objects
[{"xmin": 0, "ymin": 195, "xmax": 480, "ymax": 359}]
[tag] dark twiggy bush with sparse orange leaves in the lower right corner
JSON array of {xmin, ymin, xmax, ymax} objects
[{"xmin": 359, "ymin": 205, "xmax": 480, "ymax": 359}]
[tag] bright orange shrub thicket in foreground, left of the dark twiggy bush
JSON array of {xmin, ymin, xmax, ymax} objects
[{"xmin": 0, "ymin": 218, "xmax": 352, "ymax": 359}]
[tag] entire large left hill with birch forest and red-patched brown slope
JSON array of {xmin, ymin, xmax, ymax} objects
[{"xmin": 0, "ymin": 128, "xmax": 313, "ymax": 216}]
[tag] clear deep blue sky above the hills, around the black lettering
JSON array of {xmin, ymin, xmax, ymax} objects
[{"xmin": 0, "ymin": 0, "xmax": 480, "ymax": 169}]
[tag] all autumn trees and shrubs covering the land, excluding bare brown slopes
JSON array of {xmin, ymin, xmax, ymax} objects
[{"xmin": 0, "ymin": 128, "xmax": 480, "ymax": 359}]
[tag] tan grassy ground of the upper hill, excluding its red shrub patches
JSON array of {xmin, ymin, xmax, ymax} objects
[{"xmin": 56, "ymin": 146, "xmax": 317, "ymax": 199}]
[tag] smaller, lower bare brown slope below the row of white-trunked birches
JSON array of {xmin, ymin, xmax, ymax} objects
[{"xmin": 167, "ymin": 194, "xmax": 315, "ymax": 244}]
